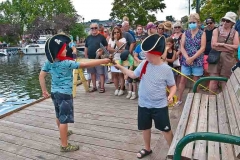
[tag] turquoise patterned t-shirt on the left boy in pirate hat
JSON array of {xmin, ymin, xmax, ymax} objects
[{"xmin": 42, "ymin": 60, "xmax": 80, "ymax": 95}]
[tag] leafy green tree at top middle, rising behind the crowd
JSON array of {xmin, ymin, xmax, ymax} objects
[{"xmin": 110, "ymin": 0, "xmax": 166, "ymax": 25}]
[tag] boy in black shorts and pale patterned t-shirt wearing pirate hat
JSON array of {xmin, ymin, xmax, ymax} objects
[{"xmin": 115, "ymin": 34, "xmax": 176, "ymax": 159}]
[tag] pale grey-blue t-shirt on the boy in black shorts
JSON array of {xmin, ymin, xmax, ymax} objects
[{"xmin": 134, "ymin": 61, "xmax": 175, "ymax": 108}]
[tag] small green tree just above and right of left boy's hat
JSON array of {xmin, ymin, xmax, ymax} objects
[{"xmin": 69, "ymin": 23, "xmax": 87, "ymax": 40}]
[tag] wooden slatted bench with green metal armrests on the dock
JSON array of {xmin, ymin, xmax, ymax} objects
[{"xmin": 167, "ymin": 68, "xmax": 240, "ymax": 160}]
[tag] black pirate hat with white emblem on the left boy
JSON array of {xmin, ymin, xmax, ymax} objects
[{"xmin": 45, "ymin": 34, "xmax": 71, "ymax": 63}]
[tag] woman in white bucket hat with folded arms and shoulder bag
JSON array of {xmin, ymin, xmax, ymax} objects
[{"xmin": 208, "ymin": 12, "xmax": 239, "ymax": 92}]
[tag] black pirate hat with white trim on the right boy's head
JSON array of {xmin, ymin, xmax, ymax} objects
[{"xmin": 141, "ymin": 34, "xmax": 165, "ymax": 56}]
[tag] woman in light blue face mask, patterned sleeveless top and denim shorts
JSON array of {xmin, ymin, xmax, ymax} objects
[{"xmin": 176, "ymin": 13, "xmax": 206, "ymax": 105}]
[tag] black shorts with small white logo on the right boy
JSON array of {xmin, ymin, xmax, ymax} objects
[{"xmin": 138, "ymin": 106, "xmax": 171, "ymax": 132}]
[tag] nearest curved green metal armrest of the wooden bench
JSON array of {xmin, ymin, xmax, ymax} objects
[{"xmin": 173, "ymin": 132, "xmax": 240, "ymax": 160}]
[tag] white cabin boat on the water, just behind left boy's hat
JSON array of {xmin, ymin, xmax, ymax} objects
[{"xmin": 21, "ymin": 35, "xmax": 52, "ymax": 55}]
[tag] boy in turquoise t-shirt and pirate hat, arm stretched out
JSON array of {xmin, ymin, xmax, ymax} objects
[{"xmin": 39, "ymin": 34, "xmax": 110, "ymax": 152}]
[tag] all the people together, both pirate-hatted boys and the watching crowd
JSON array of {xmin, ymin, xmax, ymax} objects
[{"xmin": 39, "ymin": 12, "xmax": 239, "ymax": 159}]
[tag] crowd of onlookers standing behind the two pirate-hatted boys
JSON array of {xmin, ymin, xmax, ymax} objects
[{"xmin": 85, "ymin": 12, "xmax": 239, "ymax": 105}]
